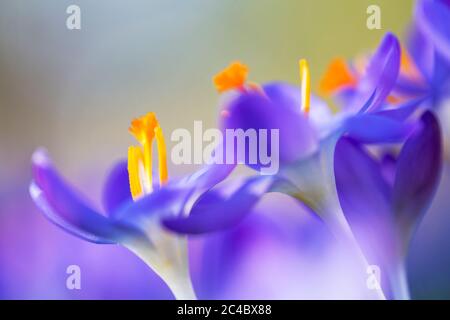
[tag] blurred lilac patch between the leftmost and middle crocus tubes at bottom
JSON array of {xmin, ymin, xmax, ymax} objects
[{"xmin": 190, "ymin": 193, "xmax": 376, "ymax": 299}]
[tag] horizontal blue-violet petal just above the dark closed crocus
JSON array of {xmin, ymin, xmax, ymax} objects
[{"xmin": 344, "ymin": 114, "xmax": 414, "ymax": 143}]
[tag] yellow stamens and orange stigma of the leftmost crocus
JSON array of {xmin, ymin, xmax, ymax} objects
[{"xmin": 128, "ymin": 112, "xmax": 168, "ymax": 199}]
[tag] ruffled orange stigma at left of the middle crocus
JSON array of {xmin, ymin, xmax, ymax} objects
[{"xmin": 213, "ymin": 61, "xmax": 248, "ymax": 93}]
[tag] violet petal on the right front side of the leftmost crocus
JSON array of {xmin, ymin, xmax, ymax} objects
[{"xmin": 163, "ymin": 176, "xmax": 274, "ymax": 234}]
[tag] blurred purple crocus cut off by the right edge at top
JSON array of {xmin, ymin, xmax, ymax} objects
[{"xmin": 395, "ymin": 0, "xmax": 450, "ymax": 109}]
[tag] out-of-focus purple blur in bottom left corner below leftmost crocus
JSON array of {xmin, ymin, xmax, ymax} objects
[{"xmin": 0, "ymin": 194, "xmax": 173, "ymax": 300}]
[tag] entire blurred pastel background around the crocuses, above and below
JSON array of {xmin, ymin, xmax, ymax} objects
[{"xmin": 0, "ymin": 0, "xmax": 450, "ymax": 299}]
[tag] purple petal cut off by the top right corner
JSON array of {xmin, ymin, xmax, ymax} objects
[{"xmin": 416, "ymin": 0, "xmax": 450, "ymax": 61}]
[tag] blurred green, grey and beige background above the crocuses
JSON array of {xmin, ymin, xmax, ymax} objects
[{"xmin": 0, "ymin": 0, "xmax": 413, "ymax": 205}]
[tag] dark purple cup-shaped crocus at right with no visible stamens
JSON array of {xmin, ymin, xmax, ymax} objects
[{"xmin": 335, "ymin": 112, "xmax": 442, "ymax": 299}]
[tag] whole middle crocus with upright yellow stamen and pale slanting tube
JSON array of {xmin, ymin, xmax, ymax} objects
[{"xmin": 204, "ymin": 34, "xmax": 422, "ymax": 297}]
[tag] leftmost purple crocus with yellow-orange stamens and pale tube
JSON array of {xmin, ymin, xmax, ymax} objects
[{"xmin": 30, "ymin": 113, "xmax": 274, "ymax": 299}]
